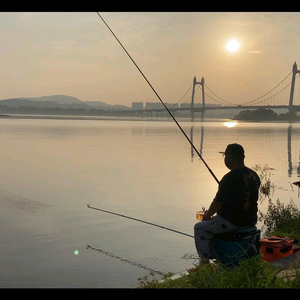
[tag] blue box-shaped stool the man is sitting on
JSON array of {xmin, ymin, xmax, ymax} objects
[{"xmin": 210, "ymin": 226, "xmax": 260, "ymax": 266}]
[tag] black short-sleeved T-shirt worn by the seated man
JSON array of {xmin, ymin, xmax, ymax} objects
[{"xmin": 214, "ymin": 167, "xmax": 260, "ymax": 227}]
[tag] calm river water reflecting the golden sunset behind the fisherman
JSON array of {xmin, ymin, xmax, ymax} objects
[{"xmin": 0, "ymin": 118, "xmax": 300, "ymax": 287}]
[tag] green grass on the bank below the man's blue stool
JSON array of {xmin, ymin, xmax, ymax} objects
[{"xmin": 139, "ymin": 255, "xmax": 300, "ymax": 289}]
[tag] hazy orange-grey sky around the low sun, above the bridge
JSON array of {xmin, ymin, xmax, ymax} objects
[{"xmin": 0, "ymin": 12, "xmax": 300, "ymax": 106}]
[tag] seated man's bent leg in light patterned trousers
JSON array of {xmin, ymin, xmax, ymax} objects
[{"xmin": 194, "ymin": 215, "xmax": 238, "ymax": 259}]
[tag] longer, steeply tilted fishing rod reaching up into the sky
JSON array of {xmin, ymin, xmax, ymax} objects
[{"xmin": 97, "ymin": 12, "xmax": 219, "ymax": 184}]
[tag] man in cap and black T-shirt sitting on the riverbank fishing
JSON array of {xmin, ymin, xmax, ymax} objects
[{"xmin": 194, "ymin": 144, "xmax": 260, "ymax": 261}]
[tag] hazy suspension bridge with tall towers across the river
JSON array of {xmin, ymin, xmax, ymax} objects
[{"xmin": 131, "ymin": 62, "xmax": 300, "ymax": 119}]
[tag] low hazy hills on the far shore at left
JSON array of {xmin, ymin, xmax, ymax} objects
[{"xmin": 0, "ymin": 95, "xmax": 130, "ymax": 110}]
